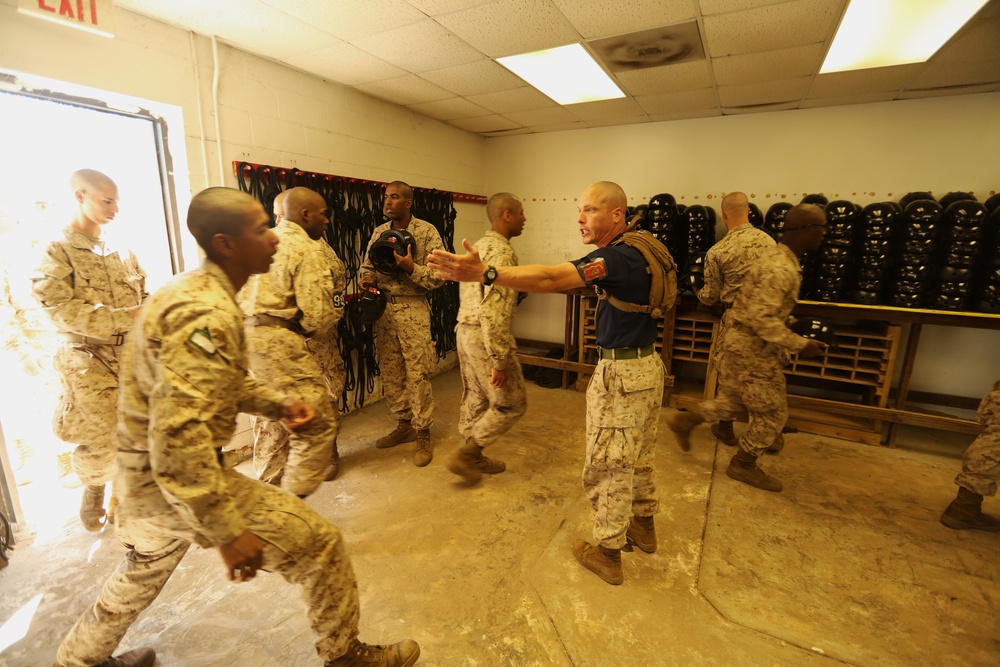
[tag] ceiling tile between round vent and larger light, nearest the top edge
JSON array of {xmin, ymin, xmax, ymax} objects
[{"xmin": 704, "ymin": 0, "xmax": 843, "ymax": 58}]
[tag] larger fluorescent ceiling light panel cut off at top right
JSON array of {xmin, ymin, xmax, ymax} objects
[{"xmin": 820, "ymin": 0, "xmax": 987, "ymax": 74}]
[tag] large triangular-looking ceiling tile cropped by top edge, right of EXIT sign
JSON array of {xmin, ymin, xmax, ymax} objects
[{"xmin": 256, "ymin": 0, "xmax": 426, "ymax": 42}]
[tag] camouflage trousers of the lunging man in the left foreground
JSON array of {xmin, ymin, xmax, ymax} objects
[{"xmin": 57, "ymin": 475, "xmax": 360, "ymax": 667}]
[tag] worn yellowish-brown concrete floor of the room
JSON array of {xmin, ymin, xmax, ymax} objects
[{"xmin": 0, "ymin": 370, "xmax": 1000, "ymax": 667}]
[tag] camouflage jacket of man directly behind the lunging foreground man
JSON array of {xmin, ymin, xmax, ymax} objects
[{"xmin": 237, "ymin": 220, "xmax": 344, "ymax": 335}]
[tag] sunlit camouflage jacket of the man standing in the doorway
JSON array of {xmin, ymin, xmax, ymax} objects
[{"xmin": 32, "ymin": 227, "xmax": 146, "ymax": 338}]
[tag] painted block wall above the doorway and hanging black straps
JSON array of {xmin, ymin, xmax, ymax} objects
[{"xmin": 0, "ymin": 0, "xmax": 485, "ymax": 266}]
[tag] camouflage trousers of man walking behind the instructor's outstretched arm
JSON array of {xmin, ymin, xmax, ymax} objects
[{"xmin": 455, "ymin": 324, "xmax": 528, "ymax": 447}]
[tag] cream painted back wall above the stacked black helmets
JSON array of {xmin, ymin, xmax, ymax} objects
[{"xmin": 486, "ymin": 93, "xmax": 1000, "ymax": 397}]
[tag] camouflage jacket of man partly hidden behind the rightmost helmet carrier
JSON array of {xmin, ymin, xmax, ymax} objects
[{"xmin": 698, "ymin": 224, "xmax": 776, "ymax": 306}]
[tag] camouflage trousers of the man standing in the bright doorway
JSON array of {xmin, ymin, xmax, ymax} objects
[{"xmin": 52, "ymin": 345, "xmax": 122, "ymax": 486}]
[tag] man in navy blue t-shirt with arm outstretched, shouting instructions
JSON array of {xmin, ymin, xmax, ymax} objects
[{"xmin": 427, "ymin": 181, "xmax": 664, "ymax": 584}]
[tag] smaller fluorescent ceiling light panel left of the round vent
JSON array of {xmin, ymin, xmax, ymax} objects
[{"xmin": 497, "ymin": 44, "xmax": 625, "ymax": 104}]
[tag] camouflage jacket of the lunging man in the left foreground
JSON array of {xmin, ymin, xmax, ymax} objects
[{"xmin": 115, "ymin": 260, "xmax": 284, "ymax": 547}]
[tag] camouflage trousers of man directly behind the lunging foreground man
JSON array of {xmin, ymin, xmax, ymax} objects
[{"xmin": 247, "ymin": 326, "xmax": 340, "ymax": 496}]
